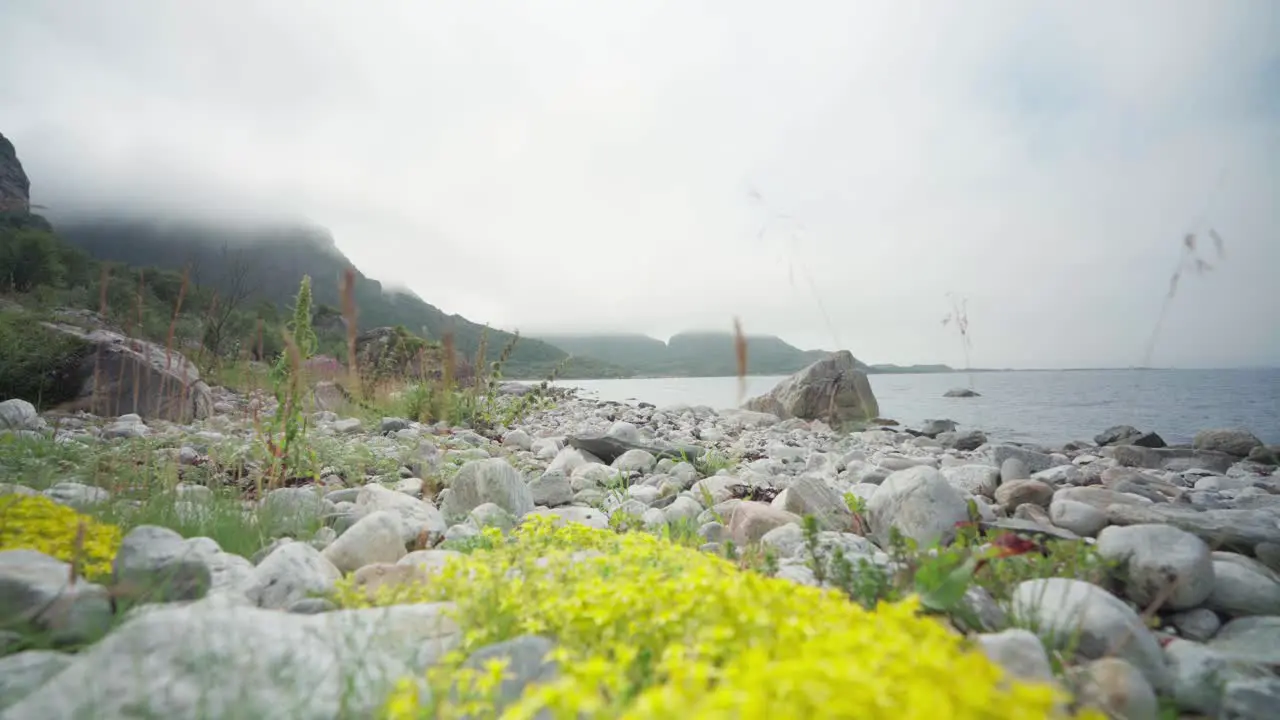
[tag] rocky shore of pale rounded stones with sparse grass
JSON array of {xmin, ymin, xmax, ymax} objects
[{"xmin": 0, "ymin": 361, "xmax": 1280, "ymax": 720}]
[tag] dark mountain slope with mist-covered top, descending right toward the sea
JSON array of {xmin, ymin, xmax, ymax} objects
[{"xmin": 55, "ymin": 218, "xmax": 628, "ymax": 377}]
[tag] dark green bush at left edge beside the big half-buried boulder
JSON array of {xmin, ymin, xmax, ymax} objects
[{"xmin": 0, "ymin": 313, "xmax": 92, "ymax": 407}]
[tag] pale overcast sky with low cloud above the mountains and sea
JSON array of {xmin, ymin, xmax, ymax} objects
[{"xmin": 0, "ymin": 0, "xmax": 1280, "ymax": 368}]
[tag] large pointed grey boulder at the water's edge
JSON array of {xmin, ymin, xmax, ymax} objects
[{"xmin": 744, "ymin": 350, "xmax": 879, "ymax": 428}]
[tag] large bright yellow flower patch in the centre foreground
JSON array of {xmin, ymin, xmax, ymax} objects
[{"xmin": 338, "ymin": 518, "xmax": 1100, "ymax": 720}]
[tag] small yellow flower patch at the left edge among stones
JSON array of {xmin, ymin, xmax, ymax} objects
[{"xmin": 0, "ymin": 495, "xmax": 123, "ymax": 582}]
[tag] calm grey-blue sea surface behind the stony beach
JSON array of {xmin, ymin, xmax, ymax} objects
[{"xmin": 557, "ymin": 369, "xmax": 1280, "ymax": 445}]
